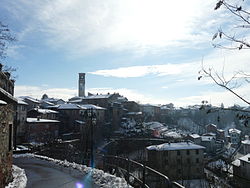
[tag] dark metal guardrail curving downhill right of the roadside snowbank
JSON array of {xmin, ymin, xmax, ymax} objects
[{"xmin": 97, "ymin": 155, "xmax": 184, "ymax": 188}]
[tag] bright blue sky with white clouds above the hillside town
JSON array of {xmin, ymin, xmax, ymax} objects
[{"xmin": 0, "ymin": 0, "xmax": 250, "ymax": 106}]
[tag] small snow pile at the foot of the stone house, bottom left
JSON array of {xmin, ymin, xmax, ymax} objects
[{"xmin": 5, "ymin": 165, "xmax": 27, "ymax": 188}]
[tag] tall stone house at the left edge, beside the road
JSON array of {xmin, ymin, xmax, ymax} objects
[{"xmin": 0, "ymin": 64, "xmax": 17, "ymax": 187}]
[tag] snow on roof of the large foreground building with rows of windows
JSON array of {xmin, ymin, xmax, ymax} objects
[{"xmin": 147, "ymin": 142, "xmax": 205, "ymax": 151}]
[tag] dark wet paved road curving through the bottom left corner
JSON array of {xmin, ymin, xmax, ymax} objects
[{"xmin": 13, "ymin": 157, "xmax": 98, "ymax": 188}]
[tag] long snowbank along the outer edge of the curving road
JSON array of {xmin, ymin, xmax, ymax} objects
[{"xmin": 13, "ymin": 154, "xmax": 131, "ymax": 188}]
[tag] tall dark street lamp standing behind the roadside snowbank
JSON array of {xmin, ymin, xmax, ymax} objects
[{"xmin": 85, "ymin": 108, "xmax": 96, "ymax": 168}]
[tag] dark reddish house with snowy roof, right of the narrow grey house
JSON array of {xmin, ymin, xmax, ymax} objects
[{"xmin": 26, "ymin": 118, "xmax": 60, "ymax": 143}]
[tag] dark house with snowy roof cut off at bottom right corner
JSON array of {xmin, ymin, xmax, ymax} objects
[{"xmin": 232, "ymin": 153, "xmax": 250, "ymax": 187}]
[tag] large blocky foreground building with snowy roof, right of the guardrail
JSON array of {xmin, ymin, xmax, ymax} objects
[{"xmin": 146, "ymin": 142, "xmax": 205, "ymax": 180}]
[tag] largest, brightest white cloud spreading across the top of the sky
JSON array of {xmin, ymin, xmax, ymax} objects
[{"xmin": 2, "ymin": 0, "xmax": 221, "ymax": 55}]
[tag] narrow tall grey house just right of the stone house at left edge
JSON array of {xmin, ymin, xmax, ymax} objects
[{"xmin": 15, "ymin": 98, "xmax": 28, "ymax": 144}]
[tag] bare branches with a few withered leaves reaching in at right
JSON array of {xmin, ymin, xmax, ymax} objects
[{"xmin": 198, "ymin": 0, "xmax": 250, "ymax": 105}]
